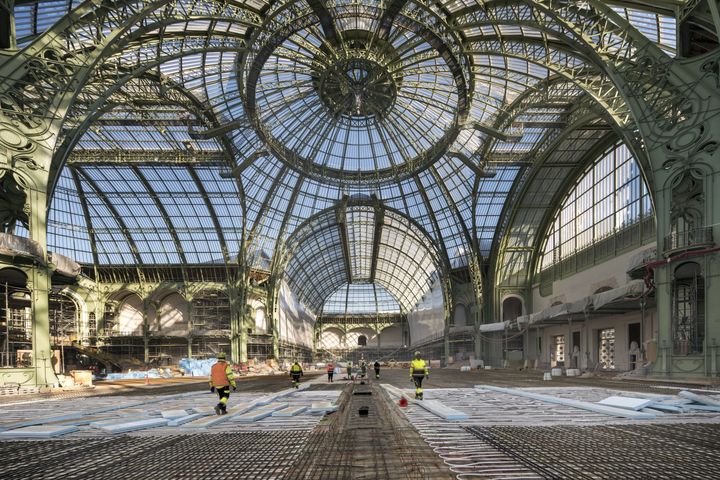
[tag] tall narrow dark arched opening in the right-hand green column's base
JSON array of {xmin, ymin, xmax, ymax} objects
[{"xmin": 672, "ymin": 262, "xmax": 705, "ymax": 355}]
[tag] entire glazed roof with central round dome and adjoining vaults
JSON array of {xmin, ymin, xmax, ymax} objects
[{"xmin": 25, "ymin": 0, "xmax": 676, "ymax": 312}]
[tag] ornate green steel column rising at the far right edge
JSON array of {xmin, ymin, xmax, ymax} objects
[{"xmin": 642, "ymin": 52, "xmax": 720, "ymax": 377}]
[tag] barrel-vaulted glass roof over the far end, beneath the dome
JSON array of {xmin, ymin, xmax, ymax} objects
[{"xmin": 284, "ymin": 204, "xmax": 443, "ymax": 312}]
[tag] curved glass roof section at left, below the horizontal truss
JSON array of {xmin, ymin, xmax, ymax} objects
[{"xmin": 48, "ymin": 164, "xmax": 242, "ymax": 265}]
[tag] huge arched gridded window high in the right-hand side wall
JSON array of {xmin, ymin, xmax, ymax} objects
[{"xmin": 538, "ymin": 144, "xmax": 653, "ymax": 270}]
